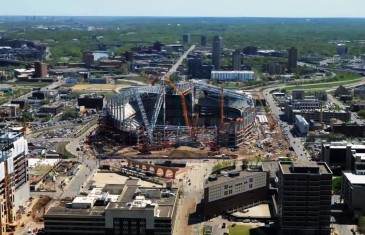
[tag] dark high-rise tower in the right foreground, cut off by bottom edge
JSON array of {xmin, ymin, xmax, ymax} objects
[{"xmin": 278, "ymin": 162, "xmax": 332, "ymax": 235}]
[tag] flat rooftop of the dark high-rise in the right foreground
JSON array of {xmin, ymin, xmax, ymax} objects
[{"xmin": 279, "ymin": 161, "xmax": 332, "ymax": 174}]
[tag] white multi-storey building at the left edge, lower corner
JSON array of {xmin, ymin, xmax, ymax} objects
[{"xmin": 0, "ymin": 126, "xmax": 29, "ymax": 235}]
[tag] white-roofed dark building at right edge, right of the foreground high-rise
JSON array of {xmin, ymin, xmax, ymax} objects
[{"xmin": 341, "ymin": 171, "xmax": 365, "ymax": 218}]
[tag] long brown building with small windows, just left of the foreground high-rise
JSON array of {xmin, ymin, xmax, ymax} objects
[{"xmin": 203, "ymin": 170, "xmax": 269, "ymax": 219}]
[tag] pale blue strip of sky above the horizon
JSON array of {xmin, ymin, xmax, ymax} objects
[{"xmin": 0, "ymin": 0, "xmax": 365, "ymax": 18}]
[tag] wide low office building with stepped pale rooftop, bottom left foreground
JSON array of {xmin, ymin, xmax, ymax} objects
[{"xmin": 44, "ymin": 180, "xmax": 178, "ymax": 235}]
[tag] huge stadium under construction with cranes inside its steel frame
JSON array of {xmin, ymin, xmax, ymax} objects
[{"xmin": 103, "ymin": 79, "xmax": 255, "ymax": 148}]
